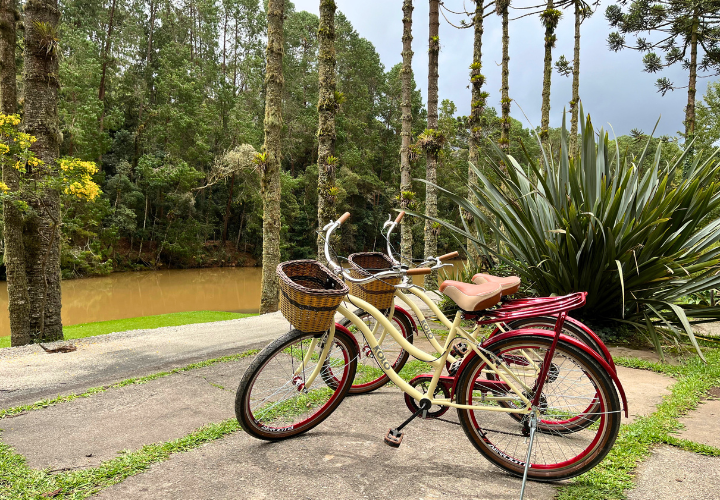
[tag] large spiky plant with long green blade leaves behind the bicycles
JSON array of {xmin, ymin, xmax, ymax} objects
[{"xmin": 418, "ymin": 109, "xmax": 720, "ymax": 357}]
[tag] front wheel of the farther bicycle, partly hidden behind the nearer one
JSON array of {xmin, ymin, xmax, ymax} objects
[{"xmin": 340, "ymin": 308, "xmax": 413, "ymax": 394}]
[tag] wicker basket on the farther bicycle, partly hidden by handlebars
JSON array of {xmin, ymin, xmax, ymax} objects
[{"xmin": 348, "ymin": 252, "xmax": 400, "ymax": 310}]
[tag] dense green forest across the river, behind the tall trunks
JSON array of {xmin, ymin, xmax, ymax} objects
[{"xmin": 1, "ymin": 0, "xmax": 708, "ymax": 278}]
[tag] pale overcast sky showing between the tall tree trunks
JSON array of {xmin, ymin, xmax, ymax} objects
[{"xmin": 293, "ymin": 0, "xmax": 712, "ymax": 138}]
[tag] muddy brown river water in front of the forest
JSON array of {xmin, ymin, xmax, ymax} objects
[{"xmin": 0, "ymin": 262, "xmax": 470, "ymax": 337}]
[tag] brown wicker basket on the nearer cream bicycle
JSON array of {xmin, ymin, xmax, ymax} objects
[{"xmin": 277, "ymin": 260, "xmax": 348, "ymax": 333}]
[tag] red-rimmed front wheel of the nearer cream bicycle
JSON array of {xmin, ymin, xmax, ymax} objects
[{"xmin": 235, "ymin": 329, "xmax": 357, "ymax": 441}]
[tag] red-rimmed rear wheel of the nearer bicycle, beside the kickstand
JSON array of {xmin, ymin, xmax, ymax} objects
[{"xmin": 455, "ymin": 334, "xmax": 620, "ymax": 481}]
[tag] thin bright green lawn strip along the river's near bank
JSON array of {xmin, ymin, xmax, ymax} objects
[{"xmin": 0, "ymin": 311, "xmax": 256, "ymax": 348}]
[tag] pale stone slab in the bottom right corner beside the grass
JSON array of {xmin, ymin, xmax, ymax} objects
[{"xmin": 627, "ymin": 446, "xmax": 720, "ymax": 500}]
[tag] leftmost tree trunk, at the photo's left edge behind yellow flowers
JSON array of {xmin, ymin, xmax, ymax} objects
[{"xmin": 0, "ymin": 0, "xmax": 31, "ymax": 346}]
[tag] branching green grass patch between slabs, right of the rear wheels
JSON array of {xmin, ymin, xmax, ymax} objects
[{"xmin": 557, "ymin": 350, "xmax": 720, "ymax": 500}]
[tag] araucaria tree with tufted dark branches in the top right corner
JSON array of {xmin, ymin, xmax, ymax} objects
[{"xmin": 605, "ymin": 0, "xmax": 720, "ymax": 152}]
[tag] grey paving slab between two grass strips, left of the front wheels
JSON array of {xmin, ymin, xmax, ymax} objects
[{"xmin": 0, "ymin": 358, "xmax": 252, "ymax": 470}]
